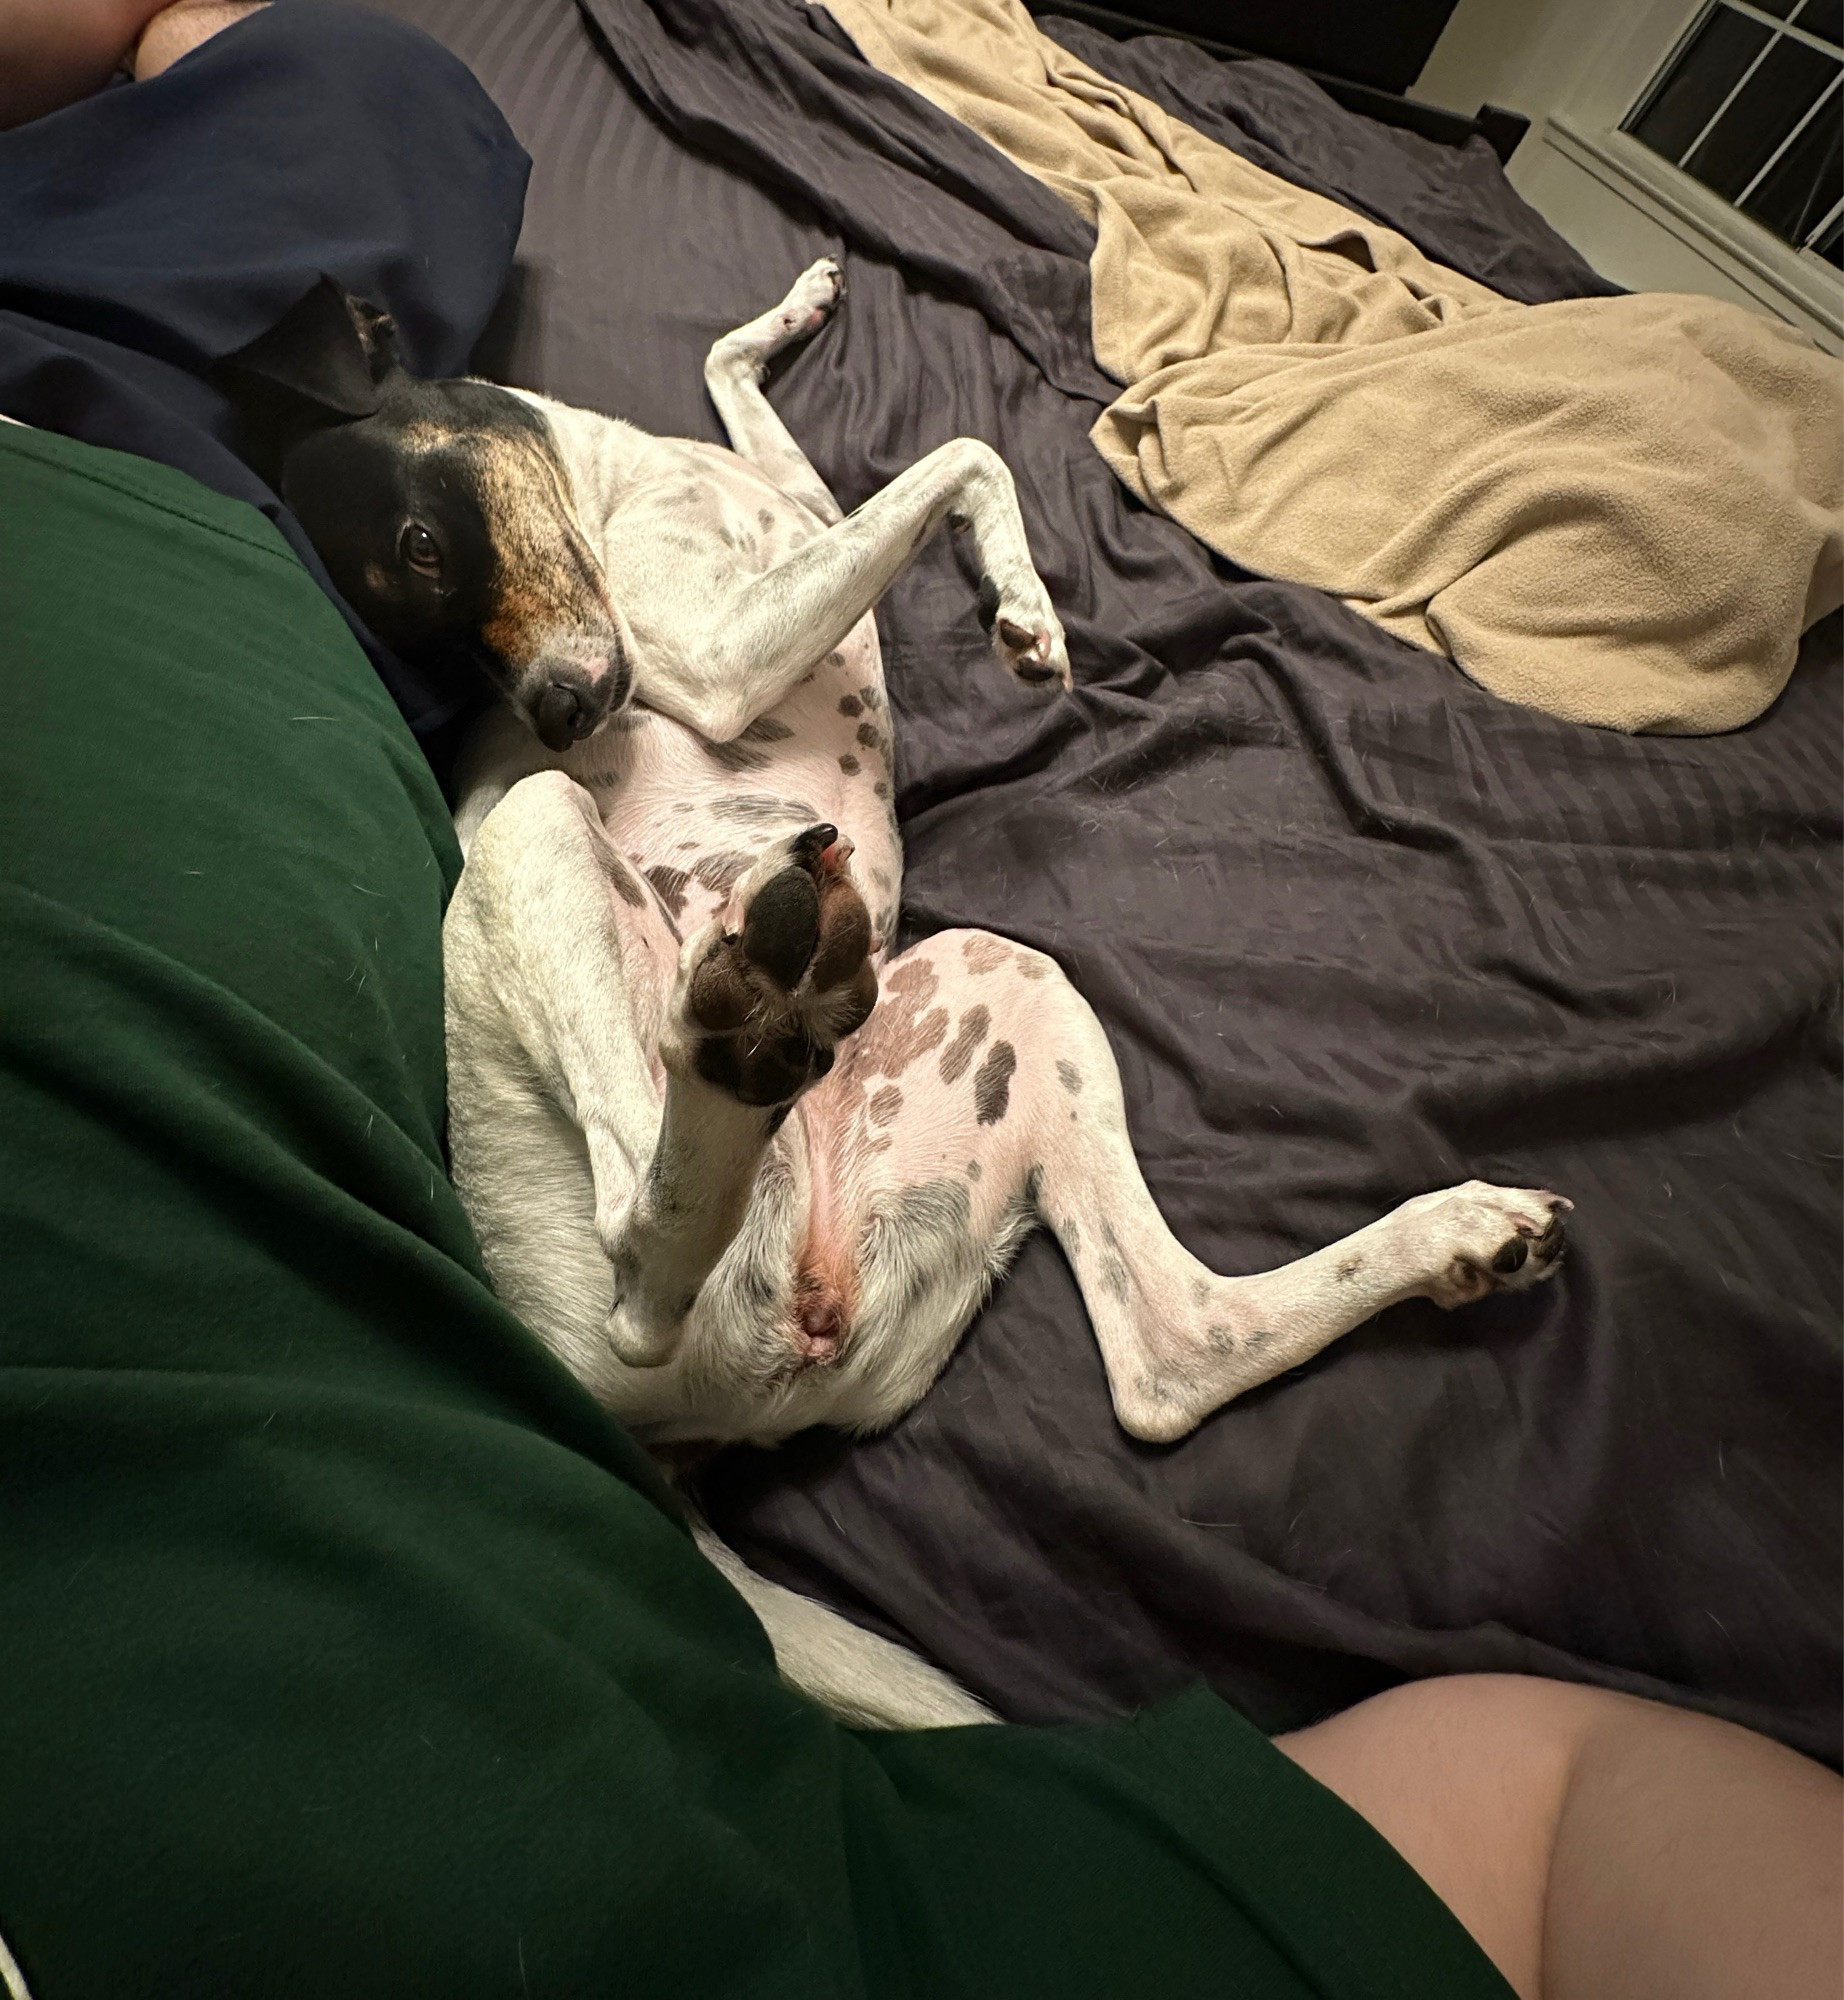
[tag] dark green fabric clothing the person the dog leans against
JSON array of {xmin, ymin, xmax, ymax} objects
[{"xmin": 0, "ymin": 426, "xmax": 1504, "ymax": 2000}]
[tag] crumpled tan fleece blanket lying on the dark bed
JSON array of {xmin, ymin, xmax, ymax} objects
[{"xmin": 826, "ymin": 0, "xmax": 1844, "ymax": 734}]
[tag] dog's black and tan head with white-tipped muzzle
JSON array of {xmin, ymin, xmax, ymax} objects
[{"xmin": 224, "ymin": 278, "xmax": 630, "ymax": 750}]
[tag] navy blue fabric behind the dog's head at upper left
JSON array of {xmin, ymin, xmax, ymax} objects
[{"xmin": 0, "ymin": 0, "xmax": 530, "ymax": 736}]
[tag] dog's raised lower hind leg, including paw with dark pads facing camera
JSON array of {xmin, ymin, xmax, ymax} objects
[{"xmin": 606, "ymin": 826, "xmax": 878, "ymax": 1368}]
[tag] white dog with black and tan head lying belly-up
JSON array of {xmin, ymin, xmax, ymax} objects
[{"xmin": 244, "ymin": 260, "xmax": 1568, "ymax": 1708}]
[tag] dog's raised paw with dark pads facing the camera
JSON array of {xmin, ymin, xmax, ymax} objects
[{"xmin": 660, "ymin": 826, "xmax": 878, "ymax": 1106}]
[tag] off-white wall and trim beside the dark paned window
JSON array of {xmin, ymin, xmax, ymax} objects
[{"xmin": 1412, "ymin": 0, "xmax": 1844, "ymax": 352}]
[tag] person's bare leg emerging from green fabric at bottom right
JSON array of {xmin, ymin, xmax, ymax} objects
[{"xmin": 1276, "ymin": 1674, "xmax": 1844, "ymax": 2000}]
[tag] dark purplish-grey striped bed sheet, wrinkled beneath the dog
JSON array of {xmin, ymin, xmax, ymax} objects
[{"xmin": 338, "ymin": 0, "xmax": 1844, "ymax": 1764}]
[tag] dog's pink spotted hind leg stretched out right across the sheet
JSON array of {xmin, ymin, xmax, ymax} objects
[{"xmin": 858, "ymin": 932, "xmax": 1568, "ymax": 1442}]
